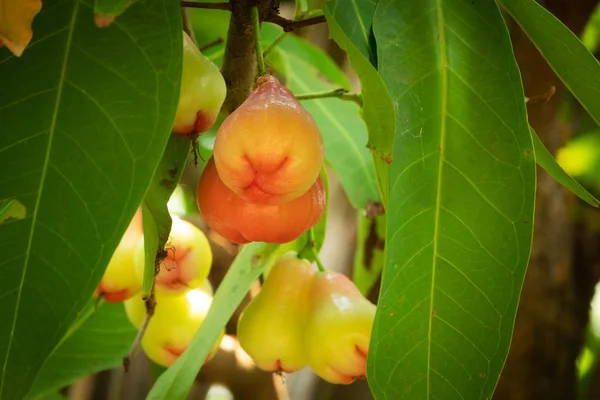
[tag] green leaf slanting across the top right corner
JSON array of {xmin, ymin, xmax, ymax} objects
[{"xmin": 499, "ymin": 0, "xmax": 600, "ymax": 124}]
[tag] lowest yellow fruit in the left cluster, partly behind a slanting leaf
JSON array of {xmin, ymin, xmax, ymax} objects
[{"xmin": 124, "ymin": 282, "xmax": 225, "ymax": 367}]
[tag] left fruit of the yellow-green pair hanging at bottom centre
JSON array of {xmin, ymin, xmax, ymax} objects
[{"xmin": 237, "ymin": 252, "xmax": 315, "ymax": 372}]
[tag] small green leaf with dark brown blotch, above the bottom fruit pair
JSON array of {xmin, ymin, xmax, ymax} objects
[{"xmin": 352, "ymin": 210, "xmax": 386, "ymax": 296}]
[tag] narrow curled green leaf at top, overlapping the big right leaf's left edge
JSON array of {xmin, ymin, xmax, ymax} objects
[{"xmin": 323, "ymin": 0, "xmax": 396, "ymax": 163}]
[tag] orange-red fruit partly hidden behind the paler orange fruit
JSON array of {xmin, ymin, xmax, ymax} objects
[{"xmin": 196, "ymin": 158, "xmax": 326, "ymax": 243}]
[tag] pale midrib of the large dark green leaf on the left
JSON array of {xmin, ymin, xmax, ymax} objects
[{"xmin": 0, "ymin": 0, "xmax": 79, "ymax": 397}]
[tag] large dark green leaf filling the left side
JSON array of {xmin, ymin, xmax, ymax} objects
[{"xmin": 0, "ymin": 0, "xmax": 182, "ymax": 400}]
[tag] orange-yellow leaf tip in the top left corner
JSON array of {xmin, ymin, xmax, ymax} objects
[{"xmin": 0, "ymin": 0, "xmax": 42, "ymax": 57}]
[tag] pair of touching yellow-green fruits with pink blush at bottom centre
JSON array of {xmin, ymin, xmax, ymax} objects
[{"xmin": 237, "ymin": 252, "xmax": 375, "ymax": 384}]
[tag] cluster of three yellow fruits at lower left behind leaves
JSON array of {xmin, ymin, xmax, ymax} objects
[{"xmin": 94, "ymin": 211, "xmax": 224, "ymax": 367}]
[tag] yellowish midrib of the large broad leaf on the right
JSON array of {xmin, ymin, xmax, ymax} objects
[{"xmin": 426, "ymin": 0, "xmax": 448, "ymax": 399}]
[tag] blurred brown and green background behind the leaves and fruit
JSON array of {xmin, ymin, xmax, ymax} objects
[{"xmin": 50, "ymin": 0, "xmax": 600, "ymax": 400}]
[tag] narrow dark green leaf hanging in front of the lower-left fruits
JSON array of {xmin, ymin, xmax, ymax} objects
[{"xmin": 142, "ymin": 135, "xmax": 191, "ymax": 298}]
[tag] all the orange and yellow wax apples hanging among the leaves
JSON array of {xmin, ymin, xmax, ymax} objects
[{"xmin": 95, "ymin": 33, "xmax": 375, "ymax": 384}]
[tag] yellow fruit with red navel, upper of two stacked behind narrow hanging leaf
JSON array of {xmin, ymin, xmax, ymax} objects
[{"xmin": 134, "ymin": 215, "xmax": 213, "ymax": 293}]
